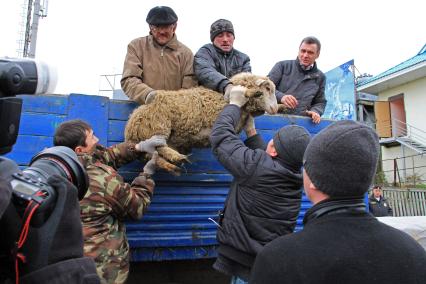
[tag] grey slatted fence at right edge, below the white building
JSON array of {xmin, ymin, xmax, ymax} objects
[{"xmin": 383, "ymin": 188, "xmax": 426, "ymax": 217}]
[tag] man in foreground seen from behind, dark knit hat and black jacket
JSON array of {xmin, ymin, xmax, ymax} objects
[{"xmin": 250, "ymin": 121, "xmax": 426, "ymax": 284}]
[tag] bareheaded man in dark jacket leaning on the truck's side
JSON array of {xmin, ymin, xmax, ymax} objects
[{"xmin": 268, "ymin": 36, "xmax": 327, "ymax": 123}]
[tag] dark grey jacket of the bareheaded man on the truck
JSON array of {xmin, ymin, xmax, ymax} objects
[{"xmin": 268, "ymin": 59, "xmax": 327, "ymax": 115}]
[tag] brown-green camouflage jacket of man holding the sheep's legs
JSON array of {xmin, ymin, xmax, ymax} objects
[{"xmin": 79, "ymin": 143, "xmax": 155, "ymax": 283}]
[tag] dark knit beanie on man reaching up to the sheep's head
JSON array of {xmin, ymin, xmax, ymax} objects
[{"xmin": 273, "ymin": 125, "xmax": 311, "ymax": 171}]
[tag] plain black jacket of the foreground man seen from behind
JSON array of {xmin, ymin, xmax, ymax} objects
[{"xmin": 250, "ymin": 197, "xmax": 426, "ymax": 284}]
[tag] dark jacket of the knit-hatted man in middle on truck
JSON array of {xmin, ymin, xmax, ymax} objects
[{"xmin": 194, "ymin": 43, "xmax": 251, "ymax": 93}]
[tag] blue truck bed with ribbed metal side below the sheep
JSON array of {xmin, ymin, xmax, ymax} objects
[{"xmin": 7, "ymin": 94, "xmax": 331, "ymax": 261}]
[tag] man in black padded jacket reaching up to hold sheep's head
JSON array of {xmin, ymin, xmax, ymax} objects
[{"xmin": 210, "ymin": 86, "xmax": 310, "ymax": 283}]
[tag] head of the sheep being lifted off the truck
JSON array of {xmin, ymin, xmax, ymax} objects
[{"xmin": 230, "ymin": 73, "xmax": 278, "ymax": 116}]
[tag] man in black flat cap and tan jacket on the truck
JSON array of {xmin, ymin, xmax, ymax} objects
[{"xmin": 121, "ymin": 6, "xmax": 197, "ymax": 104}]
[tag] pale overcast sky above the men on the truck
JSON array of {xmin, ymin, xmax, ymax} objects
[{"xmin": 0, "ymin": 0, "xmax": 426, "ymax": 95}]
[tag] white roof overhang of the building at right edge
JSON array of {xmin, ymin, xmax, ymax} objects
[{"xmin": 357, "ymin": 61, "xmax": 426, "ymax": 95}]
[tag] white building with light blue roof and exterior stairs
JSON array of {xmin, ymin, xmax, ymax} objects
[{"xmin": 357, "ymin": 44, "xmax": 426, "ymax": 184}]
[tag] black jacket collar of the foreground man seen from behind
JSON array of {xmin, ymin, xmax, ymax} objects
[{"xmin": 303, "ymin": 196, "xmax": 367, "ymax": 225}]
